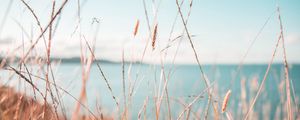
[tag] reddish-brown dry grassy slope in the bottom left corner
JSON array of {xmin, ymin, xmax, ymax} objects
[{"xmin": 0, "ymin": 86, "xmax": 56, "ymax": 120}]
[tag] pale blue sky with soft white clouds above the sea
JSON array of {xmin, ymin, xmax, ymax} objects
[{"xmin": 0, "ymin": 0, "xmax": 300, "ymax": 64}]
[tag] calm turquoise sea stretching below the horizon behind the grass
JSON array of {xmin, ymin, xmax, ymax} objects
[{"xmin": 0, "ymin": 62, "xmax": 300, "ymax": 119}]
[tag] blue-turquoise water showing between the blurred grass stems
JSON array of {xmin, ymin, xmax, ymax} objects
[{"xmin": 2, "ymin": 63, "xmax": 300, "ymax": 119}]
